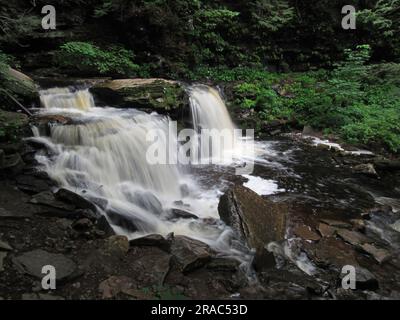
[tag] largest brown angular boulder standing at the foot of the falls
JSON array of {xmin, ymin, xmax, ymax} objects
[{"xmin": 218, "ymin": 186, "xmax": 288, "ymax": 251}]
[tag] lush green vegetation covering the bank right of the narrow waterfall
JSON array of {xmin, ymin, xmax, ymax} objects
[{"xmin": 187, "ymin": 45, "xmax": 400, "ymax": 153}]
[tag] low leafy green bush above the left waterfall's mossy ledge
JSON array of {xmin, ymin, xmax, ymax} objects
[{"xmin": 56, "ymin": 42, "xmax": 139, "ymax": 76}]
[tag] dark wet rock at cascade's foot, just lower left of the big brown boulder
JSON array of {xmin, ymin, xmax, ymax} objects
[{"xmin": 171, "ymin": 236, "xmax": 212, "ymax": 273}]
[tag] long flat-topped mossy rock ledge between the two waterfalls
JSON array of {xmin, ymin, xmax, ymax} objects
[{"xmin": 91, "ymin": 79, "xmax": 188, "ymax": 113}]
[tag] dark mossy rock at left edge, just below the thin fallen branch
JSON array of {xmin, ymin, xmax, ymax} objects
[{"xmin": 0, "ymin": 110, "xmax": 29, "ymax": 142}]
